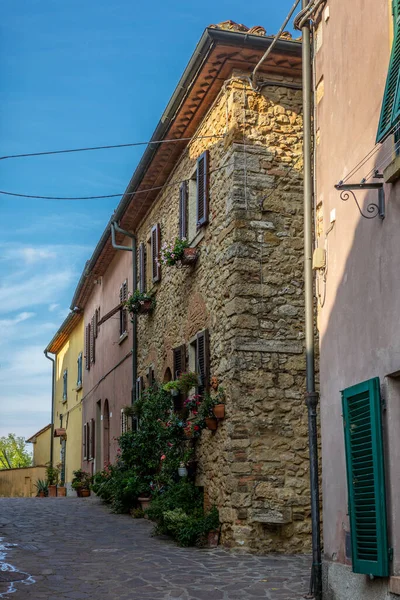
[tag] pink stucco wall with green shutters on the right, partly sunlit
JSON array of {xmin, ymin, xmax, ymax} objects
[{"xmin": 316, "ymin": 0, "xmax": 400, "ymax": 573}]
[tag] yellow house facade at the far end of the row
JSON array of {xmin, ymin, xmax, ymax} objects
[{"xmin": 45, "ymin": 312, "xmax": 84, "ymax": 495}]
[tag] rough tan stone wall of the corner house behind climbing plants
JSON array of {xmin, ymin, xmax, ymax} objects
[{"xmin": 134, "ymin": 73, "xmax": 311, "ymax": 552}]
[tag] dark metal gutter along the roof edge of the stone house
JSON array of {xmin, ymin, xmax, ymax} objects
[{"xmin": 70, "ymin": 27, "xmax": 301, "ymax": 310}]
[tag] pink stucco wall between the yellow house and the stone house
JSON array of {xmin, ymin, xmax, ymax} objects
[{"xmin": 82, "ymin": 244, "xmax": 132, "ymax": 471}]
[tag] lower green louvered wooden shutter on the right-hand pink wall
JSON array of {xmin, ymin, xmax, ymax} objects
[{"xmin": 342, "ymin": 377, "xmax": 389, "ymax": 577}]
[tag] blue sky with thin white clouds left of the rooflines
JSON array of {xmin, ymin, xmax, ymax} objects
[{"xmin": 0, "ymin": 0, "xmax": 292, "ymax": 437}]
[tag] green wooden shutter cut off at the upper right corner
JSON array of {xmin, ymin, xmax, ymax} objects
[{"xmin": 376, "ymin": 0, "xmax": 400, "ymax": 142}]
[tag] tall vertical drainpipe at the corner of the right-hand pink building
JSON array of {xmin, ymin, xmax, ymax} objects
[{"xmin": 302, "ymin": 5, "xmax": 322, "ymax": 600}]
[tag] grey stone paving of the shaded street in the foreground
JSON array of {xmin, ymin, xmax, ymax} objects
[{"xmin": 0, "ymin": 498, "xmax": 311, "ymax": 600}]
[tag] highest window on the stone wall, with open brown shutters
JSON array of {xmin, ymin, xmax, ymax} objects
[{"xmin": 184, "ymin": 150, "xmax": 209, "ymax": 242}]
